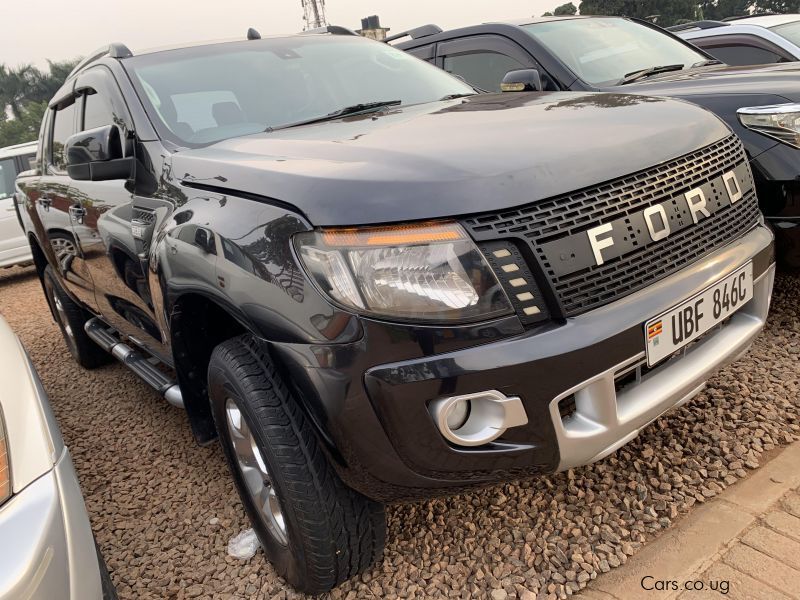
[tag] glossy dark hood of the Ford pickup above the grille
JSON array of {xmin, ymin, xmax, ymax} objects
[{"xmin": 172, "ymin": 92, "xmax": 730, "ymax": 226}]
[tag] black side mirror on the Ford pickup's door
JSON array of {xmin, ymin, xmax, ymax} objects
[{"xmin": 64, "ymin": 125, "xmax": 133, "ymax": 181}]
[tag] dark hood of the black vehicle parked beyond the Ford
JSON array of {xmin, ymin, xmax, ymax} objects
[{"xmin": 605, "ymin": 63, "xmax": 800, "ymax": 102}]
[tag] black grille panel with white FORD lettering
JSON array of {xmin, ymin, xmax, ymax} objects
[{"xmin": 541, "ymin": 164, "xmax": 753, "ymax": 276}]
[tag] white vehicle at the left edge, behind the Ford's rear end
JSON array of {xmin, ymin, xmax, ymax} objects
[{"xmin": 0, "ymin": 142, "xmax": 36, "ymax": 267}]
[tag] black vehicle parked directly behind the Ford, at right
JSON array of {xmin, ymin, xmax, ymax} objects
[{"xmin": 390, "ymin": 16, "xmax": 800, "ymax": 267}]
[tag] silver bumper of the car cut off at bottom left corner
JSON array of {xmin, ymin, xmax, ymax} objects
[{"xmin": 0, "ymin": 449, "xmax": 103, "ymax": 600}]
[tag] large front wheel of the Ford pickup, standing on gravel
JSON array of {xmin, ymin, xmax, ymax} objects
[{"xmin": 208, "ymin": 335, "xmax": 386, "ymax": 594}]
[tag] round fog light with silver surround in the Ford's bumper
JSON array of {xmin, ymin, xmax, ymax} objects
[{"xmin": 428, "ymin": 390, "xmax": 528, "ymax": 446}]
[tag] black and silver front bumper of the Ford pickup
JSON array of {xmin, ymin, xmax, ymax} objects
[{"xmin": 275, "ymin": 226, "xmax": 774, "ymax": 500}]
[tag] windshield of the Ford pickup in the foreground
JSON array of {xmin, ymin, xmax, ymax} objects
[{"xmin": 124, "ymin": 35, "xmax": 474, "ymax": 146}]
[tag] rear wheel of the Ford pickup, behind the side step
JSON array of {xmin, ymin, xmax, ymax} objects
[{"xmin": 42, "ymin": 265, "xmax": 112, "ymax": 369}]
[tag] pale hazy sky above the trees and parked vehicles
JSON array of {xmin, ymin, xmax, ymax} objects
[{"xmin": 0, "ymin": 0, "xmax": 565, "ymax": 67}]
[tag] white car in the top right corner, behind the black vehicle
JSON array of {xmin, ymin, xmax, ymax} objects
[{"xmin": 669, "ymin": 15, "xmax": 800, "ymax": 66}]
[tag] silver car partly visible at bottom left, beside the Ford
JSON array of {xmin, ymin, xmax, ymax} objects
[{"xmin": 0, "ymin": 317, "xmax": 116, "ymax": 600}]
